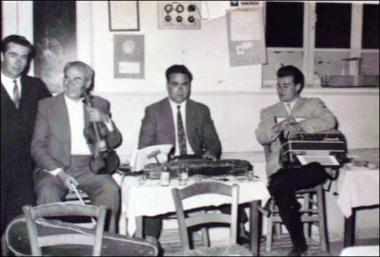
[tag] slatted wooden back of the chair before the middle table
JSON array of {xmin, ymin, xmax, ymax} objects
[{"xmin": 172, "ymin": 182, "xmax": 239, "ymax": 250}]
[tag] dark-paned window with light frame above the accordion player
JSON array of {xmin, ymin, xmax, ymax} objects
[{"xmin": 263, "ymin": 2, "xmax": 379, "ymax": 88}]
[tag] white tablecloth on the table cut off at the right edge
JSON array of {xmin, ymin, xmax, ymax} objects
[{"xmin": 337, "ymin": 164, "xmax": 379, "ymax": 217}]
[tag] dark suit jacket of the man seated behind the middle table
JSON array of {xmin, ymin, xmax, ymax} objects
[{"xmin": 138, "ymin": 98, "xmax": 222, "ymax": 158}]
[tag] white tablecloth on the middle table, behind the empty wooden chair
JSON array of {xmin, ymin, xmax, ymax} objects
[{"xmin": 119, "ymin": 177, "xmax": 270, "ymax": 235}]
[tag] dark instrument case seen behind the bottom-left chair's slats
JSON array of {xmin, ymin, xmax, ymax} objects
[{"xmin": 2, "ymin": 212, "xmax": 159, "ymax": 256}]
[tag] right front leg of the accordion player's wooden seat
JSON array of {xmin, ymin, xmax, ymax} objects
[{"xmin": 317, "ymin": 186, "xmax": 329, "ymax": 252}]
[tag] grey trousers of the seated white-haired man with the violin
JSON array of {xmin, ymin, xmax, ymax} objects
[{"xmin": 34, "ymin": 155, "xmax": 120, "ymax": 233}]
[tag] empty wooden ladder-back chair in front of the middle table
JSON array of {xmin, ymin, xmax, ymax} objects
[{"xmin": 172, "ymin": 182, "xmax": 252, "ymax": 256}]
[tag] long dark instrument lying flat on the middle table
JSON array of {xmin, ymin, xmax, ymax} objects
[{"xmin": 144, "ymin": 159, "xmax": 253, "ymax": 179}]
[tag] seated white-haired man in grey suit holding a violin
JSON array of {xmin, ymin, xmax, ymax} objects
[{"xmin": 31, "ymin": 61, "xmax": 122, "ymax": 232}]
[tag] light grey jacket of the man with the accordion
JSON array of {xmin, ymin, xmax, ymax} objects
[{"xmin": 255, "ymin": 97, "xmax": 336, "ymax": 176}]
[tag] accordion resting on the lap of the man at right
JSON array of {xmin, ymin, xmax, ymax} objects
[{"xmin": 280, "ymin": 130, "xmax": 347, "ymax": 168}]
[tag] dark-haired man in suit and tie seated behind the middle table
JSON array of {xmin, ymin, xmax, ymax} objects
[{"xmin": 138, "ymin": 65, "xmax": 248, "ymax": 242}]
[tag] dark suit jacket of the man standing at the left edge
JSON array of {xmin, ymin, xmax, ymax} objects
[{"xmin": 0, "ymin": 76, "xmax": 51, "ymax": 170}]
